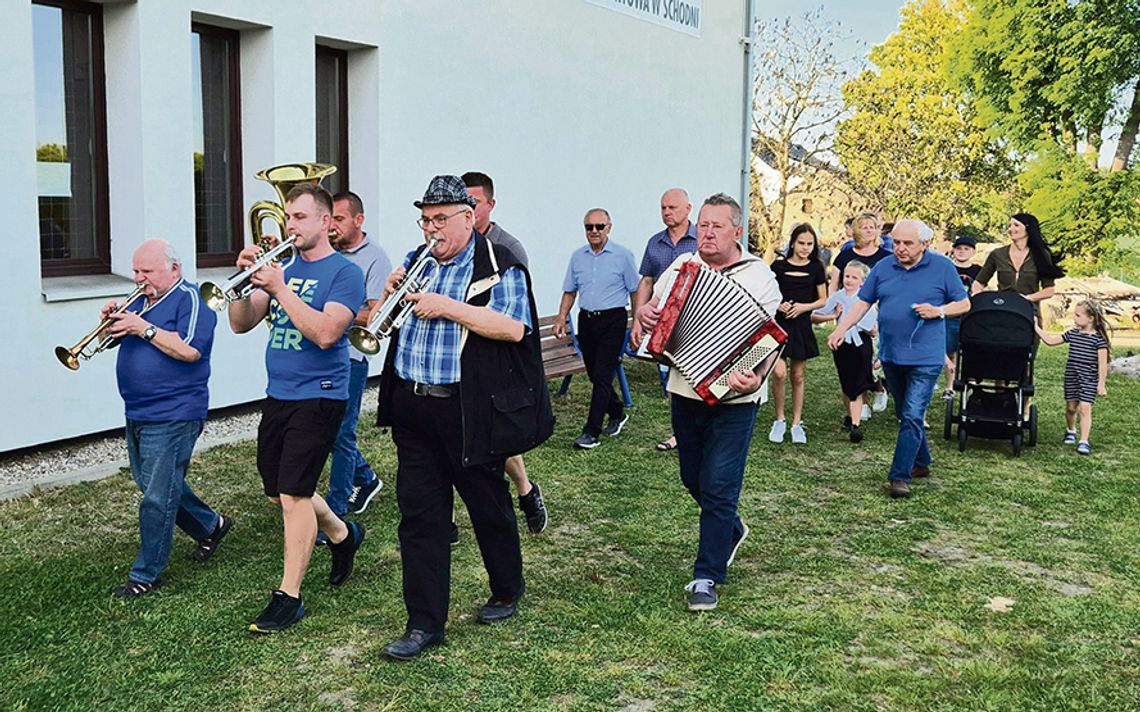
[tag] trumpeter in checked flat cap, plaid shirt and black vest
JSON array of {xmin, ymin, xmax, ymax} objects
[{"xmin": 376, "ymin": 175, "xmax": 554, "ymax": 660}]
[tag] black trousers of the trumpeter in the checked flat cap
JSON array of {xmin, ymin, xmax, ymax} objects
[{"xmin": 392, "ymin": 386, "xmax": 523, "ymax": 632}]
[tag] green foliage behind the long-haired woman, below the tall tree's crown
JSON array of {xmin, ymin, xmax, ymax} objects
[{"xmin": 1018, "ymin": 145, "xmax": 1140, "ymax": 275}]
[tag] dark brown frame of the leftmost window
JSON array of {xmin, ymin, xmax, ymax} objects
[{"xmin": 32, "ymin": 0, "xmax": 111, "ymax": 278}]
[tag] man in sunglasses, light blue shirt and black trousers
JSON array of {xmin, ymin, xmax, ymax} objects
[{"xmin": 553, "ymin": 207, "xmax": 638, "ymax": 450}]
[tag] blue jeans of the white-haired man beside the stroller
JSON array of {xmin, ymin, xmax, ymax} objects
[{"xmin": 882, "ymin": 362, "xmax": 942, "ymax": 482}]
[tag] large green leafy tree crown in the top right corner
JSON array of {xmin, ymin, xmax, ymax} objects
[{"xmin": 950, "ymin": 0, "xmax": 1140, "ymax": 171}]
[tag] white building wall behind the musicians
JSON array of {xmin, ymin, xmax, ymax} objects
[{"xmin": 0, "ymin": 0, "xmax": 747, "ymax": 451}]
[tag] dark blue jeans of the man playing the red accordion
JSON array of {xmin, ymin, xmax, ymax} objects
[{"xmin": 670, "ymin": 395, "xmax": 758, "ymax": 583}]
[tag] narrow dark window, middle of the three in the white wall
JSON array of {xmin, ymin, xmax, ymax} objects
[{"xmin": 192, "ymin": 24, "xmax": 244, "ymax": 267}]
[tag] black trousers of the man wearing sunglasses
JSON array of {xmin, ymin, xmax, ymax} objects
[{"xmin": 578, "ymin": 306, "xmax": 628, "ymax": 437}]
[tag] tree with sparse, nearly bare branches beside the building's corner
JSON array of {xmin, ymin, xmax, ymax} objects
[{"xmin": 749, "ymin": 10, "xmax": 853, "ymax": 254}]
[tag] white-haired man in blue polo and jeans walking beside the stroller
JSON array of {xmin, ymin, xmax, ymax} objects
[{"xmin": 828, "ymin": 220, "xmax": 970, "ymax": 498}]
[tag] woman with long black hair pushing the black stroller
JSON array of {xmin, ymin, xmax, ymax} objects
[{"xmin": 972, "ymin": 213, "xmax": 1065, "ymax": 305}]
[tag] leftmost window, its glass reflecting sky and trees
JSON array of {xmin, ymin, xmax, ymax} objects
[{"xmin": 32, "ymin": 0, "xmax": 111, "ymax": 277}]
